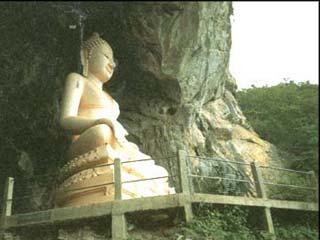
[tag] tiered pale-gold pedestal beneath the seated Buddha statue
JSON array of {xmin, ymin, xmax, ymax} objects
[{"xmin": 55, "ymin": 146, "xmax": 175, "ymax": 207}]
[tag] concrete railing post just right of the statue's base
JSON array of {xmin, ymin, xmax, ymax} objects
[{"xmin": 178, "ymin": 150, "xmax": 193, "ymax": 222}]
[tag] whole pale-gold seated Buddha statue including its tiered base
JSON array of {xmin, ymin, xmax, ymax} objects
[{"xmin": 55, "ymin": 33, "xmax": 175, "ymax": 207}]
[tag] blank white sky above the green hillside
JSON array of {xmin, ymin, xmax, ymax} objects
[{"xmin": 229, "ymin": 1, "xmax": 319, "ymax": 89}]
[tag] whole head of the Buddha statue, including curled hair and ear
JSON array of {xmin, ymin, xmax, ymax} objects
[{"xmin": 81, "ymin": 33, "xmax": 116, "ymax": 82}]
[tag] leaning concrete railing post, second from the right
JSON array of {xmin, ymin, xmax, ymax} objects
[{"xmin": 250, "ymin": 162, "xmax": 276, "ymax": 239}]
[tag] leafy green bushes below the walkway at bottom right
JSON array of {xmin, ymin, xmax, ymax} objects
[{"xmin": 185, "ymin": 205, "xmax": 319, "ymax": 240}]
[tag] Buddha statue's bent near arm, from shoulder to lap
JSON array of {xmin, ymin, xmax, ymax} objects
[{"xmin": 60, "ymin": 73, "xmax": 113, "ymax": 134}]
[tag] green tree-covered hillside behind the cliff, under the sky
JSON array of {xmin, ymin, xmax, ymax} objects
[{"xmin": 236, "ymin": 81, "xmax": 319, "ymax": 172}]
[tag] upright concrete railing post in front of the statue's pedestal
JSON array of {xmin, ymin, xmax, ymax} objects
[{"xmin": 112, "ymin": 158, "xmax": 127, "ymax": 240}]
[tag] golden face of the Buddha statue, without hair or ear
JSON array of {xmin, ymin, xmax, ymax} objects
[{"xmin": 88, "ymin": 44, "xmax": 115, "ymax": 83}]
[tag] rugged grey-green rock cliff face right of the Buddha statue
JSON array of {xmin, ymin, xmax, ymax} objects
[{"xmin": 109, "ymin": 2, "xmax": 278, "ymax": 184}]
